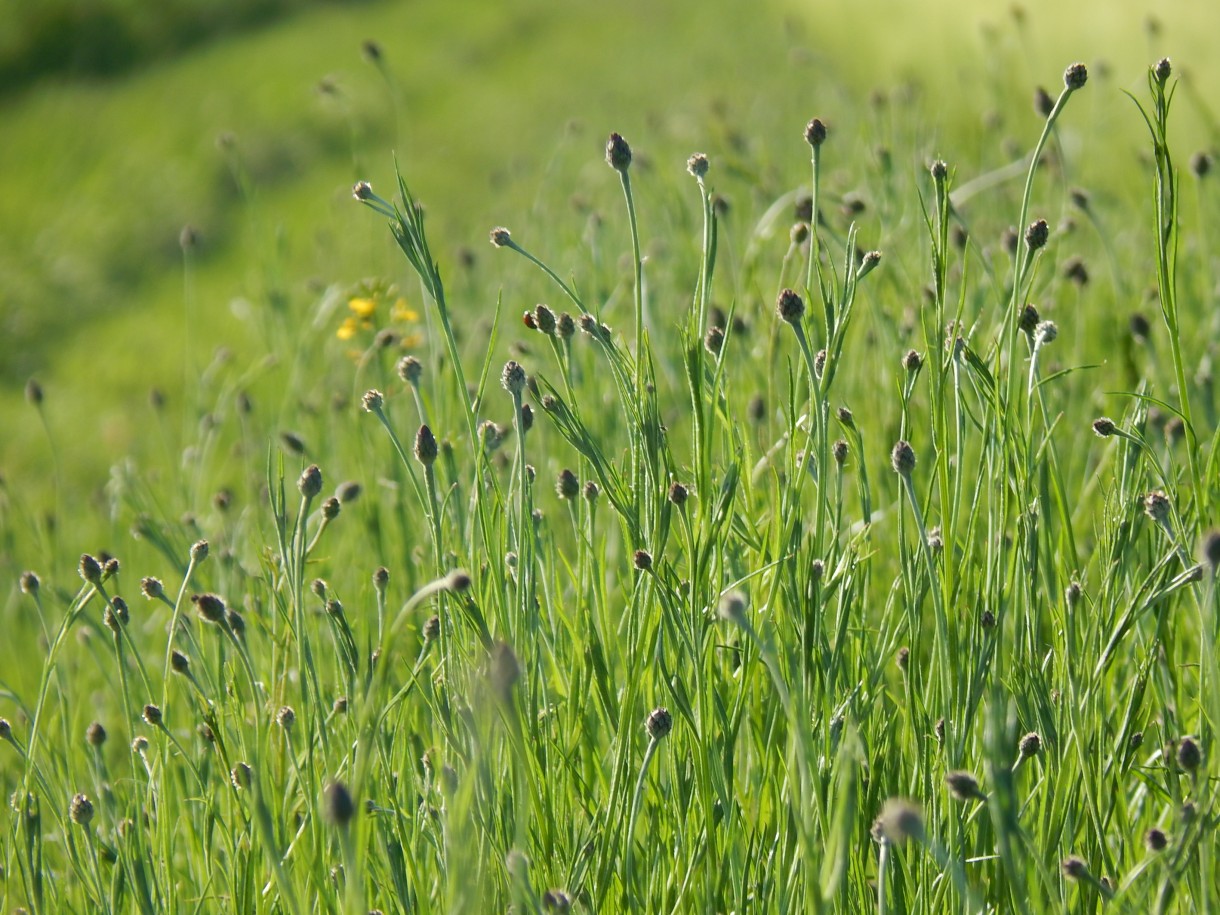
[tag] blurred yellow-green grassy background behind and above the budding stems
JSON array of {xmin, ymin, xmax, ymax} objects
[{"xmin": 0, "ymin": 0, "xmax": 1220, "ymax": 551}]
